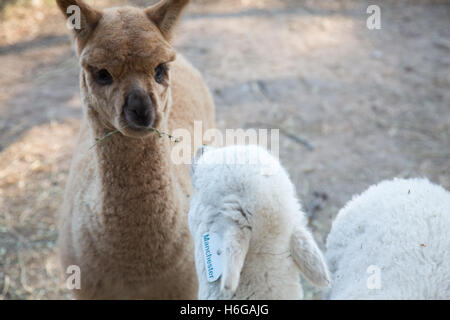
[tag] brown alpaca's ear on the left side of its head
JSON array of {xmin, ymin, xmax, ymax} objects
[{"xmin": 56, "ymin": 0, "xmax": 102, "ymax": 41}]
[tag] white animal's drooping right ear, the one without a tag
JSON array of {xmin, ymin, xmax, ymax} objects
[{"xmin": 291, "ymin": 225, "xmax": 331, "ymax": 288}]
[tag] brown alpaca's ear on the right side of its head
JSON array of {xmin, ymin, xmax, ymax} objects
[{"xmin": 145, "ymin": 0, "xmax": 189, "ymax": 40}]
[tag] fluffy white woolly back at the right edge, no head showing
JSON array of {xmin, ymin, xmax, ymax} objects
[{"xmin": 324, "ymin": 179, "xmax": 450, "ymax": 299}]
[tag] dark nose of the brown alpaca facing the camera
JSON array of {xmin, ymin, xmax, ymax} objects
[{"xmin": 123, "ymin": 89, "xmax": 155, "ymax": 129}]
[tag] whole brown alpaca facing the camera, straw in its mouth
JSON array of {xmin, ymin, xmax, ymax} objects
[{"xmin": 57, "ymin": 0, "xmax": 214, "ymax": 299}]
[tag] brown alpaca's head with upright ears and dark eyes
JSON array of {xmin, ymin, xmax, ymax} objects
[{"xmin": 57, "ymin": 0, "xmax": 189, "ymax": 137}]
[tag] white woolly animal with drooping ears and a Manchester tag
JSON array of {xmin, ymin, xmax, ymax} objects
[{"xmin": 189, "ymin": 146, "xmax": 329, "ymax": 299}]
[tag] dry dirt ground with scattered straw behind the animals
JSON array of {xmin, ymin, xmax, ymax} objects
[{"xmin": 0, "ymin": 0, "xmax": 450, "ymax": 299}]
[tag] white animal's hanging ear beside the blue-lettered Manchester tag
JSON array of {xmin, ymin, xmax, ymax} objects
[{"xmin": 220, "ymin": 225, "xmax": 251, "ymax": 297}]
